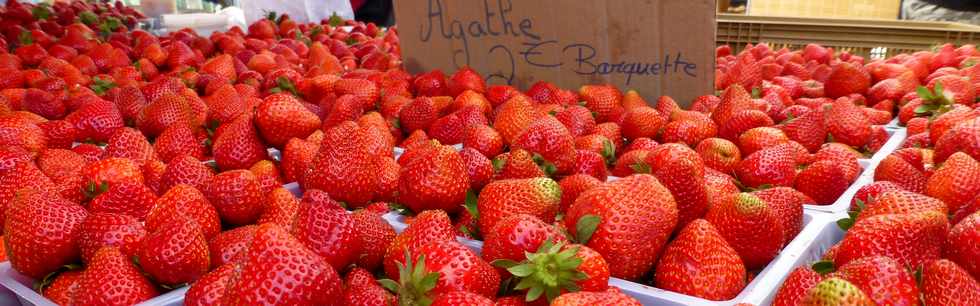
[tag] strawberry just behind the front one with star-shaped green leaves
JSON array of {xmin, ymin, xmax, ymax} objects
[{"xmin": 481, "ymin": 213, "xmax": 568, "ymax": 262}]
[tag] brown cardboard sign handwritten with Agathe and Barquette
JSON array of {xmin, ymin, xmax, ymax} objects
[{"xmin": 394, "ymin": 0, "xmax": 715, "ymax": 106}]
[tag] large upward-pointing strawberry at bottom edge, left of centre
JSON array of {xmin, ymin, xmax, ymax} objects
[{"xmin": 221, "ymin": 223, "xmax": 343, "ymax": 305}]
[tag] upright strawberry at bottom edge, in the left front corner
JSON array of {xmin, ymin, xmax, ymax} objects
[{"xmin": 73, "ymin": 247, "xmax": 159, "ymax": 305}]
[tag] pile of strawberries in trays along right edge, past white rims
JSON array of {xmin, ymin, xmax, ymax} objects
[{"xmin": 773, "ymin": 45, "xmax": 980, "ymax": 305}]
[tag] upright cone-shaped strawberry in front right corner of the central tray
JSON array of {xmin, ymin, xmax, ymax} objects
[{"xmin": 655, "ymin": 219, "xmax": 745, "ymax": 301}]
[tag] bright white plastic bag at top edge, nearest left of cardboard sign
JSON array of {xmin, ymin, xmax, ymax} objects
[{"xmin": 238, "ymin": 0, "xmax": 354, "ymax": 24}]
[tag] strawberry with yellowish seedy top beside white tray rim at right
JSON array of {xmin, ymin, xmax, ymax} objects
[{"xmin": 705, "ymin": 193, "xmax": 785, "ymax": 269}]
